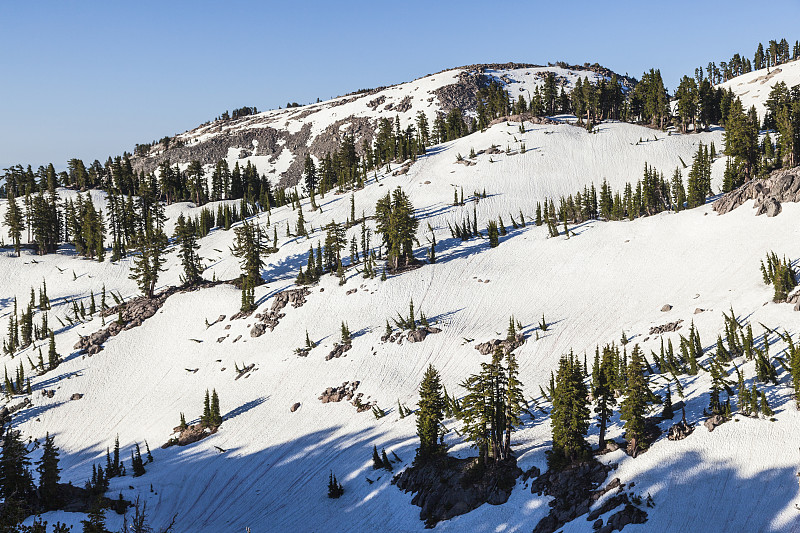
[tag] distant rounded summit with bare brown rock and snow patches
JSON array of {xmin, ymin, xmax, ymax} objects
[{"xmin": 132, "ymin": 63, "xmax": 628, "ymax": 184}]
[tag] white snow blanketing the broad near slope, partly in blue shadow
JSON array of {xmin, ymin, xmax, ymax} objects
[{"xmin": 0, "ymin": 113, "xmax": 800, "ymax": 533}]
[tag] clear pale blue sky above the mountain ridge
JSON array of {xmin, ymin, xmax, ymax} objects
[{"xmin": 0, "ymin": 0, "xmax": 800, "ymax": 169}]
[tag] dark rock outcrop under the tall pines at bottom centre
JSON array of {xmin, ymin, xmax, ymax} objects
[{"xmin": 392, "ymin": 456, "xmax": 522, "ymax": 527}]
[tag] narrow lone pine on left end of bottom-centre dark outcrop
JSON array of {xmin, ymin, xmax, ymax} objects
[{"xmin": 415, "ymin": 365, "xmax": 446, "ymax": 462}]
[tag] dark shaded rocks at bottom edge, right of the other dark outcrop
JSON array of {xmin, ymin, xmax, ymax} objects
[{"xmin": 531, "ymin": 460, "xmax": 647, "ymax": 533}]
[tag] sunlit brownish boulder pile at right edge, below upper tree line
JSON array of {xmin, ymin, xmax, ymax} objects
[{"xmin": 713, "ymin": 167, "xmax": 800, "ymax": 217}]
